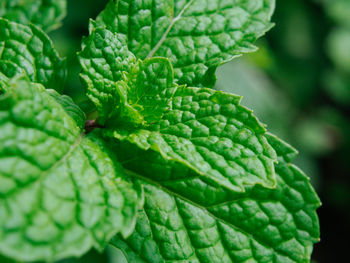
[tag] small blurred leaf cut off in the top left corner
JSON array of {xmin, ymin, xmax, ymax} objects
[{"xmin": 0, "ymin": 0, "xmax": 67, "ymax": 31}]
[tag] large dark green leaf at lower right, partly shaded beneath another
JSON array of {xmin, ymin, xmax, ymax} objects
[{"xmin": 112, "ymin": 136, "xmax": 320, "ymax": 263}]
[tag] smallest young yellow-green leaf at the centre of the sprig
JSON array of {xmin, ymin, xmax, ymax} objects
[{"xmin": 117, "ymin": 58, "xmax": 176, "ymax": 125}]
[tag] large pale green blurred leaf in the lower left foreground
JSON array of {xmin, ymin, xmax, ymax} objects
[{"xmin": 0, "ymin": 78, "xmax": 142, "ymax": 261}]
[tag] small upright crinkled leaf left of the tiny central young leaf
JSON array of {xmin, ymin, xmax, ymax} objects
[{"xmin": 78, "ymin": 22, "xmax": 136, "ymax": 123}]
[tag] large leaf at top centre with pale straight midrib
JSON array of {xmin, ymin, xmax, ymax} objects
[{"xmin": 96, "ymin": 0, "xmax": 275, "ymax": 87}]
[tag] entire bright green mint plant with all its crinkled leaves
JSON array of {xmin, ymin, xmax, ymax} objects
[{"xmin": 0, "ymin": 0, "xmax": 320, "ymax": 262}]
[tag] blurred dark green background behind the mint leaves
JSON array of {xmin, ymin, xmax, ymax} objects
[{"xmin": 18, "ymin": 0, "xmax": 350, "ymax": 263}]
